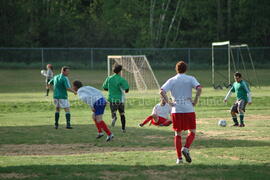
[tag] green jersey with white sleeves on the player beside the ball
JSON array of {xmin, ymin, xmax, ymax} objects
[{"xmin": 230, "ymin": 80, "xmax": 250, "ymax": 102}]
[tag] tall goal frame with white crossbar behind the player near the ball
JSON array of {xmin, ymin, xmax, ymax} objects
[{"xmin": 212, "ymin": 41, "xmax": 259, "ymax": 89}]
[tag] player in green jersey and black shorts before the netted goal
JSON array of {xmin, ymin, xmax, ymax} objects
[{"xmin": 103, "ymin": 64, "xmax": 129, "ymax": 132}]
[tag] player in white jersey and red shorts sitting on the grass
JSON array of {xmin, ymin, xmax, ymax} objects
[{"xmin": 139, "ymin": 99, "xmax": 172, "ymax": 127}]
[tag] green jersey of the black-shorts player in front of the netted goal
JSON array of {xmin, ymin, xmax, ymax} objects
[{"xmin": 103, "ymin": 74, "xmax": 129, "ymax": 102}]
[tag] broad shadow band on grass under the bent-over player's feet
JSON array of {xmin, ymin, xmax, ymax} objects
[{"xmin": 0, "ymin": 124, "xmax": 270, "ymax": 148}]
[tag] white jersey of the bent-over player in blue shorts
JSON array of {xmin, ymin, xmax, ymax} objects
[{"xmin": 77, "ymin": 86, "xmax": 104, "ymax": 107}]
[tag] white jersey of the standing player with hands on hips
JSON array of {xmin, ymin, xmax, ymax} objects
[{"xmin": 161, "ymin": 74, "xmax": 200, "ymax": 113}]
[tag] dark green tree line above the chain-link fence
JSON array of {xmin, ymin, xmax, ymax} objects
[{"xmin": 0, "ymin": 0, "xmax": 270, "ymax": 48}]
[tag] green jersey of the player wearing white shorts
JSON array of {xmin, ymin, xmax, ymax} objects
[{"xmin": 48, "ymin": 74, "xmax": 71, "ymax": 99}]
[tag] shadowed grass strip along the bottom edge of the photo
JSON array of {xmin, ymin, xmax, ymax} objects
[{"xmin": 0, "ymin": 164, "xmax": 270, "ymax": 180}]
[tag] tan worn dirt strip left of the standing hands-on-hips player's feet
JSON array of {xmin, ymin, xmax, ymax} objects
[{"xmin": 0, "ymin": 144, "xmax": 173, "ymax": 156}]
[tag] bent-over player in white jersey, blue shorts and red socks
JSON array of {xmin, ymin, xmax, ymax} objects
[{"xmin": 73, "ymin": 81, "xmax": 114, "ymax": 142}]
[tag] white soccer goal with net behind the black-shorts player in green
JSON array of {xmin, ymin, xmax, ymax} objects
[{"xmin": 107, "ymin": 55, "xmax": 160, "ymax": 91}]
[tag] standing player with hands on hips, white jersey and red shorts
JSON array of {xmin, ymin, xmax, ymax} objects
[{"xmin": 160, "ymin": 61, "xmax": 202, "ymax": 164}]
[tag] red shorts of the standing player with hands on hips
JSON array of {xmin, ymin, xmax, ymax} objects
[{"xmin": 171, "ymin": 112, "xmax": 196, "ymax": 131}]
